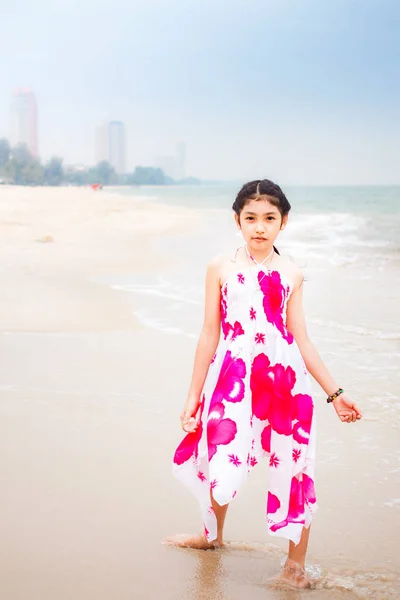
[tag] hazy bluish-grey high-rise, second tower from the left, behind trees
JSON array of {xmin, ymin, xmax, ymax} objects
[{"xmin": 95, "ymin": 121, "xmax": 126, "ymax": 173}]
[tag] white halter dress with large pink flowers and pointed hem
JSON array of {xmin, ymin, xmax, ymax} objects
[{"xmin": 174, "ymin": 248, "xmax": 317, "ymax": 544}]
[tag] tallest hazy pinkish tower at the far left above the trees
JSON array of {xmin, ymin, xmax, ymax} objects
[{"xmin": 11, "ymin": 89, "xmax": 38, "ymax": 156}]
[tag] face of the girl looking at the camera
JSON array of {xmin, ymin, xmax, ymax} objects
[{"xmin": 235, "ymin": 200, "xmax": 288, "ymax": 252}]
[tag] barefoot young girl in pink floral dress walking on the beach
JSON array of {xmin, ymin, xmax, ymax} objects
[{"xmin": 170, "ymin": 179, "xmax": 361, "ymax": 587}]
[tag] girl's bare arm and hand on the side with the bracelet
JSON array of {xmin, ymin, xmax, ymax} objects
[{"xmin": 287, "ymin": 276, "xmax": 361, "ymax": 422}]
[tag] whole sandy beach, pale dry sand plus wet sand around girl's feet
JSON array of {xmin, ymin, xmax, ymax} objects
[{"xmin": 0, "ymin": 187, "xmax": 400, "ymax": 600}]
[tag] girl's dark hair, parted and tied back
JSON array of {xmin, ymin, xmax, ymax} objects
[{"xmin": 232, "ymin": 179, "xmax": 291, "ymax": 254}]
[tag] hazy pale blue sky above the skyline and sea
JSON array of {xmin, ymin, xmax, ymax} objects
[{"xmin": 0, "ymin": 0, "xmax": 400, "ymax": 184}]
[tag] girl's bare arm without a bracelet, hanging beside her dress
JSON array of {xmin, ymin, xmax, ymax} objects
[{"xmin": 181, "ymin": 259, "xmax": 221, "ymax": 431}]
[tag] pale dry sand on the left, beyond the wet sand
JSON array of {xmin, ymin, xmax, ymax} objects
[{"xmin": 0, "ymin": 186, "xmax": 200, "ymax": 332}]
